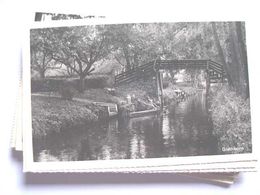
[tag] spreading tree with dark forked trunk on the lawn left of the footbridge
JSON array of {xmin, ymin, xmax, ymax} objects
[{"xmin": 53, "ymin": 26, "xmax": 109, "ymax": 92}]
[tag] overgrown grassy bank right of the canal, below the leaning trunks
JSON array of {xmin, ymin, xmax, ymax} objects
[{"xmin": 210, "ymin": 86, "xmax": 252, "ymax": 153}]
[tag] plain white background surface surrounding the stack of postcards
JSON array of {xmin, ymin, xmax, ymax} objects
[{"xmin": 0, "ymin": 0, "xmax": 260, "ymax": 195}]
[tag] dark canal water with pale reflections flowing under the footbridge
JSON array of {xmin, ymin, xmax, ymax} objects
[{"xmin": 33, "ymin": 91, "xmax": 219, "ymax": 161}]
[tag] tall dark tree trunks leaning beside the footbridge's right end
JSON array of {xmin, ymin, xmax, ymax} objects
[{"xmin": 212, "ymin": 22, "xmax": 249, "ymax": 98}]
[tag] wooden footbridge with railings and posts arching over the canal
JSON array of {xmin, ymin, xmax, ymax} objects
[{"xmin": 115, "ymin": 59, "xmax": 227, "ymax": 107}]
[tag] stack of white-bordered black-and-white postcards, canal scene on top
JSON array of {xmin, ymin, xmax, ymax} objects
[{"xmin": 11, "ymin": 12, "xmax": 257, "ymax": 184}]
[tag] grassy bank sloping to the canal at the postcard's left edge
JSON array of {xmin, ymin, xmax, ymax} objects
[{"xmin": 32, "ymin": 96, "xmax": 104, "ymax": 137}]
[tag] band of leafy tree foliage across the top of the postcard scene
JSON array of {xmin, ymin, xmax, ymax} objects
[{"xmin": 31, "ymin": 22, "xmax": 249, "ymax": 98}]
